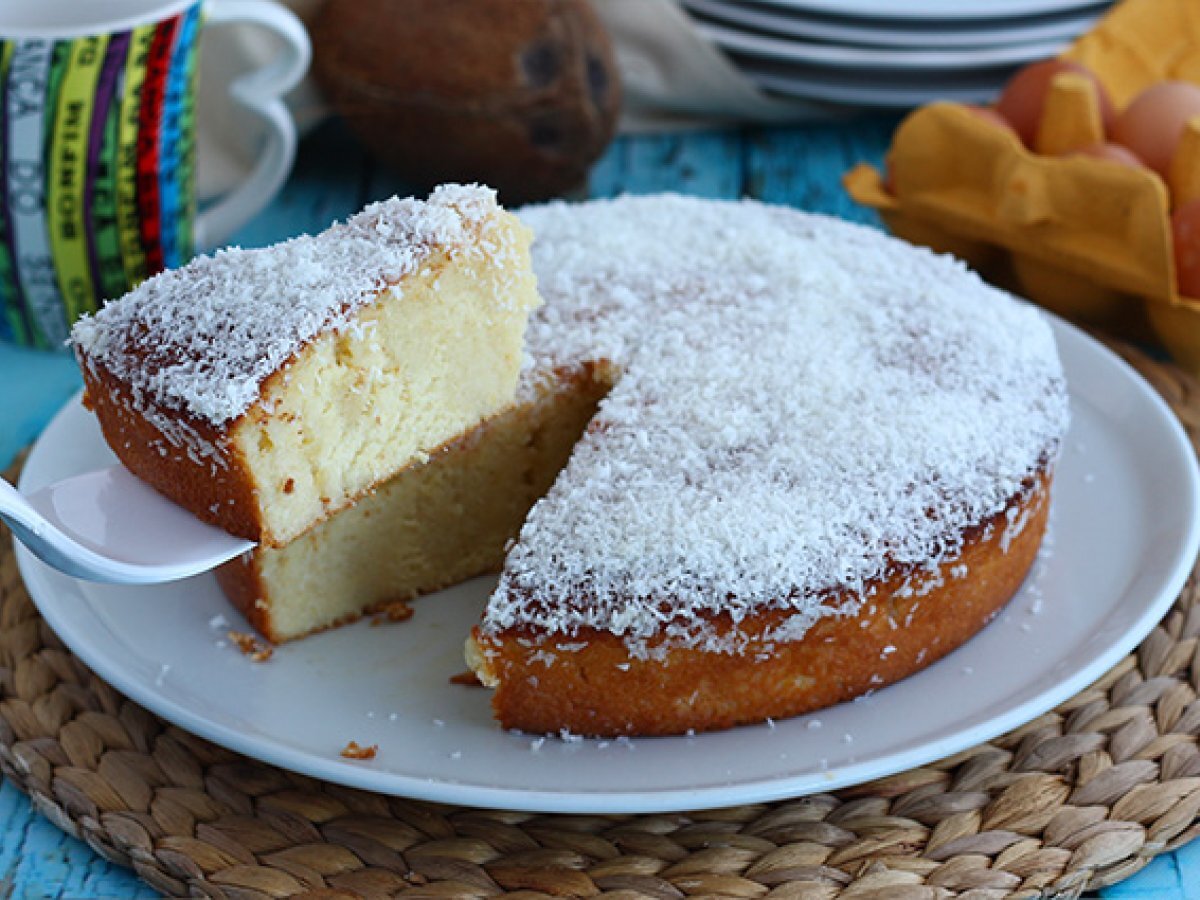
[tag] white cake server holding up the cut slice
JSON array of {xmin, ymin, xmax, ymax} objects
[{"xmin": 0, "ymin": 466, "xmax": 254, "ymax": 584}]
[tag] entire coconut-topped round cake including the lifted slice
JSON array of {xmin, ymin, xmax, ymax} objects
[{"xmin": 76, "ymin": 187, "xmax": 1068, "ymax": 734}]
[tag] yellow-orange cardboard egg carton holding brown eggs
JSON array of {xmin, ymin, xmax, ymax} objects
[{"xmin": 845, "ymin": 0, "xmax": 1200, "ymax": 373}]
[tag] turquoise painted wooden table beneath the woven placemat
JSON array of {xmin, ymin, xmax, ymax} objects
[{"xmin": 0, "ymin": 119, "xmax": 1200, "ymax": 900}]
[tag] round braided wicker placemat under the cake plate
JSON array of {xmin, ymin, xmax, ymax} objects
[{"xmin": 0, "ymin": 347, "xmax": 1200, "ymax": 900}]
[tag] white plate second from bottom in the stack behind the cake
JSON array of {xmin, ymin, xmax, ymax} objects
[{"xmin": 696, "ymin": 20, "xmax": 1067, "ymax": 69}]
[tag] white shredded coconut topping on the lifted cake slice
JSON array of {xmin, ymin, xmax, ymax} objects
[{"xmin": 71, "ymin": 185, "xmax": 506, "ymax": 426}]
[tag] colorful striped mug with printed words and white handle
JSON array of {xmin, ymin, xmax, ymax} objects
[{"xmin": 0, "ymin": 0, "xmax": 311, "ymax": 347}]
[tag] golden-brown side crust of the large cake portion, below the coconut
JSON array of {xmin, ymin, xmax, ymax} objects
[{"xmin": 468, "ymin": 470, "xmax": 1051, "ymax": 736}]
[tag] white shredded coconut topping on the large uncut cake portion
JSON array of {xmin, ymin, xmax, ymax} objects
[{"xmin": 484, "ymin": 197, "xmax": 1068, "ymax": 655}]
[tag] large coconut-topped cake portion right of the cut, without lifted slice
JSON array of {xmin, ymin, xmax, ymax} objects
[{"xmin": 467, "ymin": 197, "xmax": 1068, "ymax": 734}]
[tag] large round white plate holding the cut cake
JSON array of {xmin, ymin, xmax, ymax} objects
[{"xmin": 18, "ymin": 324, "xmax": 1200, "ymax": 812}]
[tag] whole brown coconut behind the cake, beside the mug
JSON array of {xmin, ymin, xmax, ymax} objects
[{"xmin": 313, "ymin": 0, "xmax": 620, "ymax": 204}]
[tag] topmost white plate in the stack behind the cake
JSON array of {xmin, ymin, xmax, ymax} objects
[{"xmin": 683, "ymin": 0, "xmax": 1103, "ymax": 49}]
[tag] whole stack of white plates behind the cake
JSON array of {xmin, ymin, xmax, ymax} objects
[{"xmin": 680, "ymin": 0, "xmax": 1110, "ymax": 107}]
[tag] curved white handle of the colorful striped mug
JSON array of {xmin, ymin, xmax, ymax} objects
[{"xmin": 196, "ymin": 0, "xmax": 312, "ymax": 248}]
